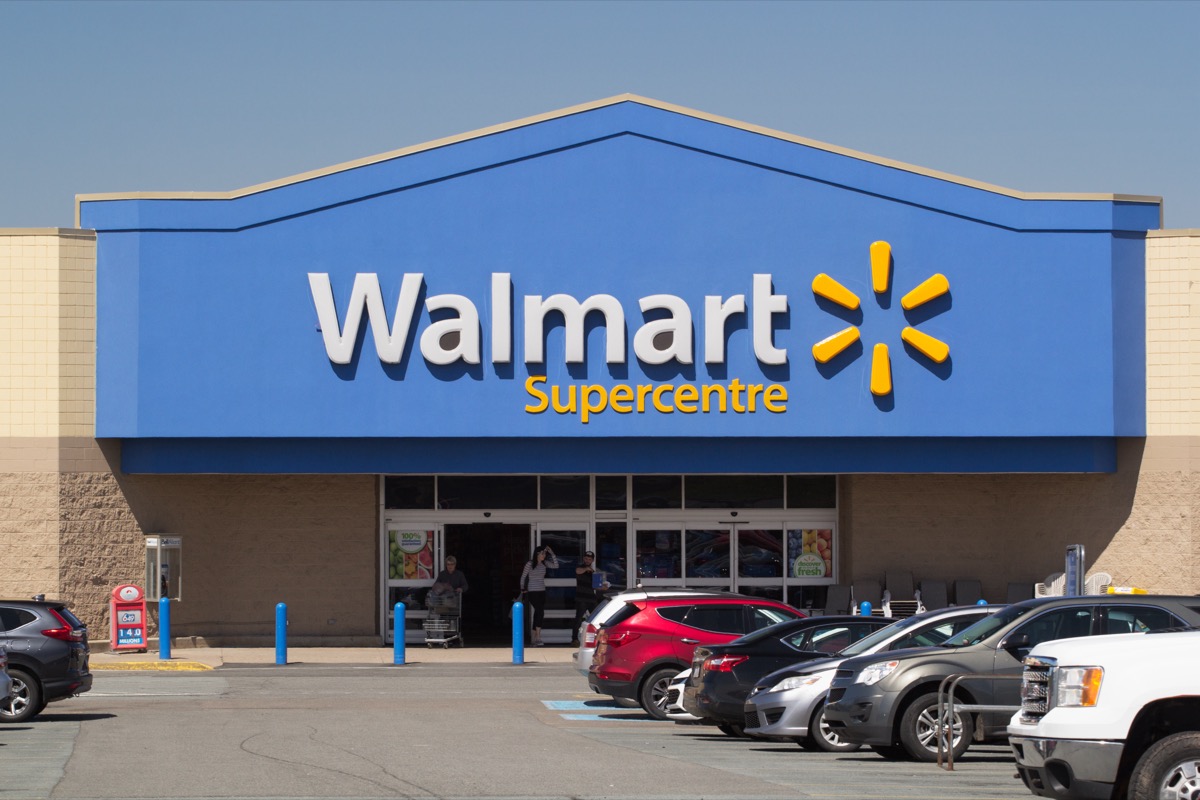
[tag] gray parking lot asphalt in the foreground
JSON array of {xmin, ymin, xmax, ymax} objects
[{"xmin": 0, "ymin": 648, "xmax": 1030, "ymax": 800}]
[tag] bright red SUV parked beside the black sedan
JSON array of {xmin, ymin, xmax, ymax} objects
[{"xmin": 588, "ymin": 593, "xmax": 804, "ymax": 720}]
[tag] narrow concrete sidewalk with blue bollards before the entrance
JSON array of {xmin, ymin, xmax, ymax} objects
[{"xmin": 89, "ymin": 643, "xmax": 578, "ymax": 670}]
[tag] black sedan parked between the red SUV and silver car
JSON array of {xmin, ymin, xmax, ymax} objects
[{"xmin": 683, "ymin": 616, "xmax": 895, "ymax": 735}]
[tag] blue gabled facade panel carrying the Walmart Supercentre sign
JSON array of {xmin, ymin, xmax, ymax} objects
[{"xmin": 80, "ymin": 100, "xmax": 1159, "ymax": 473}]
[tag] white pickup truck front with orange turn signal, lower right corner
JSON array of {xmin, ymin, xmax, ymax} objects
[{"xmin": 1008, "ymin": 630, "xmax": 1200, "ymax": 800}]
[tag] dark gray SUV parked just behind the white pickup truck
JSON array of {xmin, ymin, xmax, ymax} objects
[{"xmin": 824, "ymin": 595, "xmax": 1200, "ymax": 762}]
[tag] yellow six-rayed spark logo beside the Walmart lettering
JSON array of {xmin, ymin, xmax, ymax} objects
[{"xmin": 812, "ymin": 241, "xmax": 950, "ymax": 397}]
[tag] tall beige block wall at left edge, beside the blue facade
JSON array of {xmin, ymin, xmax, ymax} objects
[{"xmin": 0, "ymin": 229, "xmax": 96, "ymax": 606}]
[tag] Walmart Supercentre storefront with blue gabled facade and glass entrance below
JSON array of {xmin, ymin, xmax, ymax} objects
[{"xmin": 21, "ymin": 96, "xmax": 1193, "ymax": 640}]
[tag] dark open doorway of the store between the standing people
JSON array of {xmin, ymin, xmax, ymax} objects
[{"xmin": 443, "ymin": 523, "xmax": 533, "ymax": 646}]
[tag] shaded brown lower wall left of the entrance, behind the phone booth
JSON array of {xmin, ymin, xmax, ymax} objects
[{"xmin": 73, "ymin": 474, "xmax": 379, "ymax": 639}]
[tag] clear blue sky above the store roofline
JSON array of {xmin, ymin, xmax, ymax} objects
[{"xmin": 0, "ymin": 0, "xmax": 1200, "ymax": 228}]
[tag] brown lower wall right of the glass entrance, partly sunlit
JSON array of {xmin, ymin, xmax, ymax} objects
[{"xmin": 841, "ymin": 439, "xmax": 1200, "ymax": 601}]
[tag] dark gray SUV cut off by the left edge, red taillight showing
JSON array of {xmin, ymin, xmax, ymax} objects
[{"xmin": 0, "ymin": 600, "xmax": 91, "ymax": 722}]
